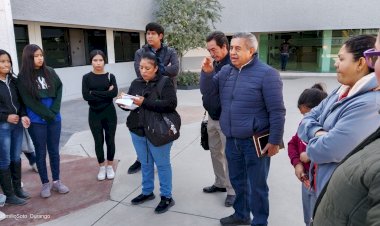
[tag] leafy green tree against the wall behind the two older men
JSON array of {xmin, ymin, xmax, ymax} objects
[{"xmin": 156, "ymin": 0, "xmax": 223, "ymax": 72}]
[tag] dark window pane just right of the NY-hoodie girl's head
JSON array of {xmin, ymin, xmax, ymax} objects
[{"xmin": 41, "ymin": 27, "xmax": 71, "ymax": 68}]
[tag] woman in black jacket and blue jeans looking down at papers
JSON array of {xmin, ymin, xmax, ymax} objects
[{"xmin": 119, "ymin": 52, "xmax": 177, "ymax": 213}]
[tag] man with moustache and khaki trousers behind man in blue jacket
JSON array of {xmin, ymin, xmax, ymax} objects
[{"xmin": 202, "ymin": 31, "xmax": 235, "ymax": 207}]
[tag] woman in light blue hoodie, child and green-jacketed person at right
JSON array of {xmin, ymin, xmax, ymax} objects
[{"xmin": 288, "ymin": 33, "xmax": 380, "ymax": 226}]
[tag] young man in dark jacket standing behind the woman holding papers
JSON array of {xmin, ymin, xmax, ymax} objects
[{"xmin": 128, "ymin": 22, "xmax": 179, "ymax": 174}]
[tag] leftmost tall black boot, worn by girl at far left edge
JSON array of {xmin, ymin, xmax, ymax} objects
[{"xmin": 0, "ymin": 169, "xmax": 26, "ymax": 206}]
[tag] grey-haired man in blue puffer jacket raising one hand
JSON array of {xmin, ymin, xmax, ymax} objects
[{"xmin": 201, "ymin": 33, "xmax": 285, "ymax": 225}]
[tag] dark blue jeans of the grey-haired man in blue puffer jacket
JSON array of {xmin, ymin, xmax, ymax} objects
[{"xmin": 226, "ymin": 138, "xmax": 270, "ymax": 225}]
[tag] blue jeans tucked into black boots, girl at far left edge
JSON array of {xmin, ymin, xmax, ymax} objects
[{"xmin": 0, "ymin": 122, "xmax": 23, "ymax": 170}]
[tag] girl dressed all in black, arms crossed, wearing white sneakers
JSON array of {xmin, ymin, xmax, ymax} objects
[{"xmin": 82, "ymin": 50, "xmax": 118, "ymax": 181}]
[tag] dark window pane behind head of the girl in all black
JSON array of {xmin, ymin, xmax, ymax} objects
[{"xmin": 84, "ymin": 29, "xmax": 107, "ymax": 64}]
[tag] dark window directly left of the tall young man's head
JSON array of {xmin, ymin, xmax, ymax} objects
[{"xmin": 113, "ymin": 31, "xmax": 140, "ymax": 62}]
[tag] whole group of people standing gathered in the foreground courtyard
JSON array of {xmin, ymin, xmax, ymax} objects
[{"xmin": 0, "ymin": 19, "xmax": 380, "ymax": 226}]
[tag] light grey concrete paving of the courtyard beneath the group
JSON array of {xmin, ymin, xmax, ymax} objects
[{"xmin": 37, "ymin": 76, "xmax": 338, "ymax": 226}]
